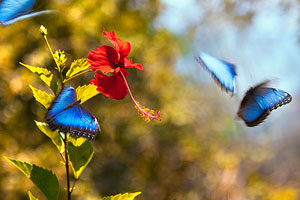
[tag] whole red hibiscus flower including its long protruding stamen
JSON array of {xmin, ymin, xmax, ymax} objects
[{"xmin": 88, "ymin": 30, "xmax": 160, "ymax": 122}]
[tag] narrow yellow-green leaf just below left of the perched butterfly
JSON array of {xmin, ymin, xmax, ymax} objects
[{"xmin": 34, "ymin": 121, "xmax": 65, "ymax": 153}]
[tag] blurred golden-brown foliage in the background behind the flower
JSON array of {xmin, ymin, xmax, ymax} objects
[{"xmin": 0, "ymin": 0, "xmax": 300, "ymax": 200}]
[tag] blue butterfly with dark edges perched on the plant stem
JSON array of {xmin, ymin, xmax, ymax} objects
[{"xmin": 45, "ymin": 86, "xmax": 100, "ymax": 140}]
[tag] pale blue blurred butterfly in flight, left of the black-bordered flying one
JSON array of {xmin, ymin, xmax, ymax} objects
[{"xmin": 196, "ymin": 52, "xmax": 236, "ymax": 94}]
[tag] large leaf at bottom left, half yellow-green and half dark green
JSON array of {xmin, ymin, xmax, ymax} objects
[{"xmin": 4, "ymin": 156, "xmax": 59, "ymax": 200}]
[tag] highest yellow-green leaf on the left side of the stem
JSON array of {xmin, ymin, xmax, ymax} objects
[{"xmin": 20, "ymin": 62, "xmax": 58, "ymax": 93}]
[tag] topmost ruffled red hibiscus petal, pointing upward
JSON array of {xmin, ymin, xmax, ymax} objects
[{"xmin": 103, "ymin": 29, "xmax": 131, "ymax": 60}]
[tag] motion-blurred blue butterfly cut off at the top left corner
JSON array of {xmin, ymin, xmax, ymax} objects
[{"xmin": 0, "ymin": 0, "xmax": 53, "ymax": 26}]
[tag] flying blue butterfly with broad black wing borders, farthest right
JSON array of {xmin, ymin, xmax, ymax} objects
[{"xmin": 237, "ymin": 81, "xmax": 292, "ymax": 127}]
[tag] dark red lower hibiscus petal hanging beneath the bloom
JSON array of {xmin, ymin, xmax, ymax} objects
[{"xmin": 91, "ymin": 73, "xmax": 128, "ymax": 100}]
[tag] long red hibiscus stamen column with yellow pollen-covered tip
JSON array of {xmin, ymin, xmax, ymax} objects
[{"xmin": 119, "ymin": 70, "xmax": 161, "ymax": 122}]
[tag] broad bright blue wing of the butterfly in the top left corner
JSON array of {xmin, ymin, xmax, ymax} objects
[{"xmin": 0, "ymin": 0, "xmax": 35, "ymax": 24}]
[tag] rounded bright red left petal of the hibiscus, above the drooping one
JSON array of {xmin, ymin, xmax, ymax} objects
[{"xmin": 88, "ymin": 45, "xmax": 118, "ymax": 73}]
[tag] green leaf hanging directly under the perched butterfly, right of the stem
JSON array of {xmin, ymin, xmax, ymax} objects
[{"xmin": 68, "ymin": 140, "xmax": 94, "ymax": 179}]
